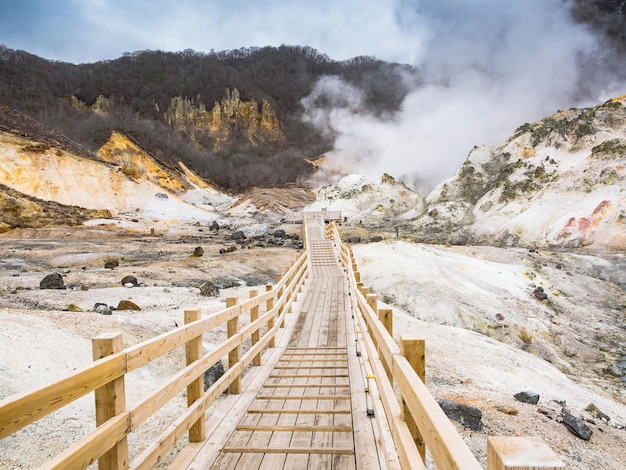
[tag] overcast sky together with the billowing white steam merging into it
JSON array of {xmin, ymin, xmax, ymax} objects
[{"xmin": 0, "ymin": 0, "xmax": 626, "ymax": 187}]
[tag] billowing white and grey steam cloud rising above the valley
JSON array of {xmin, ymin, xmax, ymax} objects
[{"xmin": 303, "ymin": 0, "xmax": 626, "ymax": 191}]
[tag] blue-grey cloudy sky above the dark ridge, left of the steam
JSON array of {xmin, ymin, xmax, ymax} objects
[{"xmin": 0, "ymin": 0, "xmax": 421, "ymax": 63}]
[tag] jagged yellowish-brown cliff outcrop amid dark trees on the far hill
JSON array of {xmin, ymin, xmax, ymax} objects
[{"xmin": 165, "ymin": 88, "xmax": 285, "ymax": 151}]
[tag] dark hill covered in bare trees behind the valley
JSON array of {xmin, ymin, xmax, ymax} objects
[{"xmin": 0, "ymin": 46, "xmax": 410, "ymax": 190}]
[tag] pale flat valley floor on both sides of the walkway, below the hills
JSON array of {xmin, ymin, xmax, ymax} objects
[{"xmin": 0, "ymin": 226, "xmax": 626, "ymax": 470}]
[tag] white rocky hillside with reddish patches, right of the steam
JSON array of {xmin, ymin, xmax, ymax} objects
[{"xmin": 413, "ymin": 96, "xmax": 626, "ymax": 250}]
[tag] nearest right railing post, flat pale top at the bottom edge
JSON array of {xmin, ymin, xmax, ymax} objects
[{"xmin": 487, "ymin": 436, "xmax": 565, "ymax": 470}]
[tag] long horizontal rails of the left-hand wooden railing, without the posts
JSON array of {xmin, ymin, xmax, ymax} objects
[{"xmin": 0, "ymin": 251, "xmax": 309, "ymax": 469}]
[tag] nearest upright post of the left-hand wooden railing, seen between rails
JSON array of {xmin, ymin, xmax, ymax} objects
[{"xmin": 91, "ymin": 333, "xmax": 128, "ymax": 470}]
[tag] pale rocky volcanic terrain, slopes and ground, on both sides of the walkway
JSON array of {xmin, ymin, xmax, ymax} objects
[{"xmin": 0, "ymin": 92, "xmax": 626, "ymax": 470}]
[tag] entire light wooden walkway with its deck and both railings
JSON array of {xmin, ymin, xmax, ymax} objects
[{"xmin": 0, "ymin": 213, "xmax": 564, "ymax": 470}]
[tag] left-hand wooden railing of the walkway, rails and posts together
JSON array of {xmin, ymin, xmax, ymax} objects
[{"xmin": 0, "ymin": 251, "xmax": 309, "ymax": 469}]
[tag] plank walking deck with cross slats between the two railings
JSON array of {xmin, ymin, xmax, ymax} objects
[{"xmin": 173, "ymin": 218, "xmax": 385, "ymax": 470}]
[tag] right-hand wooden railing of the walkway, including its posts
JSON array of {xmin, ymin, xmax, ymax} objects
[{"xmin": 326, "ymin": 223, "xmax": 565, "ymax": 470}]
